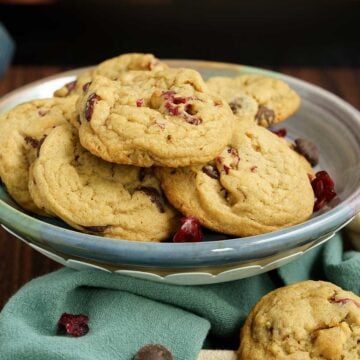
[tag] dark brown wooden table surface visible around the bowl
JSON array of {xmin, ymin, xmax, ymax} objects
[{"xmin": 0, "ymin": 66, "xmax": 360, "ymax": 309}]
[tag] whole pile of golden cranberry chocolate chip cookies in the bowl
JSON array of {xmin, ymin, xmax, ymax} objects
[{"xmin": 0, "ymin": 54, "xmax": 314, "ymax": 241}]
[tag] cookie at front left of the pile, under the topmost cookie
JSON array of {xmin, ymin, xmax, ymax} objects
[{"xmin": 29, "ymin": 124, "xmax": 177, "ymax": 241}]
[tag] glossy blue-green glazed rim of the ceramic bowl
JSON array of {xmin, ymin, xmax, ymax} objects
[{"xmin": 0, "ymin": 60, "xmax": 360, "ymax": 268}]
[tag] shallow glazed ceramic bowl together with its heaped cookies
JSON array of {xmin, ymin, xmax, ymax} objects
[{"xmin": 0, "ymin": 53, "xmax": 360, "ymax": 284}]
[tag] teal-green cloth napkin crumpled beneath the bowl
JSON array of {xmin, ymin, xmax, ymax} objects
[{"xmin": 0, "ymin": 236, "xmax": 360, "ymax": 360}]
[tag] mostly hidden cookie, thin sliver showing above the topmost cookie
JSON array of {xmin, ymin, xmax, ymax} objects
[{"xmin": 54, "ymin": 53, "xmax": 168, "ymax": 97}]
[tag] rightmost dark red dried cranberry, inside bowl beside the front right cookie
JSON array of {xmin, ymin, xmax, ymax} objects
[{"xmin": 311, "ymin": 170, "xmax": 336, "ymax": 211}]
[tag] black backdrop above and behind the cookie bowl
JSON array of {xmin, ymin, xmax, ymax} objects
[{"xmin": 0, "ymin": 0, "xmax": 360, "ymax": 67}]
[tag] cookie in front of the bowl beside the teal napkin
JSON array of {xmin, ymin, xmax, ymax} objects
[{"xmin": 238, "ymin": 281, "xmax": 360, "ymax": 360}]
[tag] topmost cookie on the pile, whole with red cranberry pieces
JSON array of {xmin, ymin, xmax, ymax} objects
[{"xmin": 77, "ymin": 69, "xmax": 234, "ymax": 167}]
